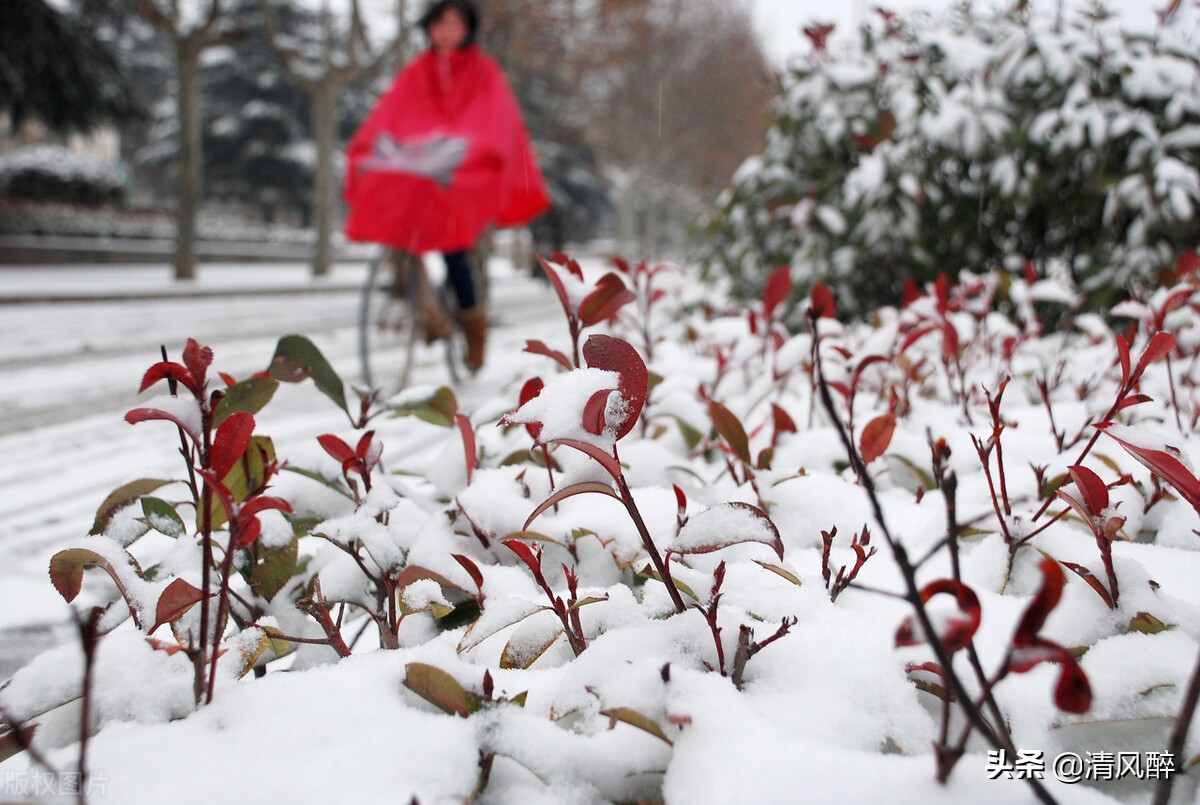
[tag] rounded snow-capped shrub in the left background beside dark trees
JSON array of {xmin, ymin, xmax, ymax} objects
[{"xmin": 0, "ymin": 145, "xmax": 127, "ymax": 206}]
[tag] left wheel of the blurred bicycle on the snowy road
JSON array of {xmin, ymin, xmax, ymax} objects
[{"xmin": 359, "ymin": 248, "xmax": 421, "ymax": 396}]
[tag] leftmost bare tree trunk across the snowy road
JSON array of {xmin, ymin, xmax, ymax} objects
[{"xmin": 175, "ymin": 40, "xmax": 204, "ymax": 280}]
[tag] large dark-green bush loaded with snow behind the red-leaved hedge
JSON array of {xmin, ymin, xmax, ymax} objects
[{"xmin": 706, "ymin": 4, "xmax": 1200, "ymax": 312}]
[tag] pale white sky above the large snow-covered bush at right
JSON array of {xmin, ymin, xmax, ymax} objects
[{"xmin": 749, "ymin": 0, "xmax": 1196, "ymax": 66}]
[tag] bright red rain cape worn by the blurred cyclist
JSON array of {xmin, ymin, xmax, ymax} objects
[{"xmin": 343, "ymin": 46, "xmax": 550, "ymax": 253}]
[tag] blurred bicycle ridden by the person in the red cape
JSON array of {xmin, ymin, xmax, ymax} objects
[{"xmin": 359, "ymin": 239, "xmax": 490, "ymax": 396}]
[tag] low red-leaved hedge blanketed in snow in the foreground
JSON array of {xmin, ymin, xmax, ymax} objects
[{"xmin": 7, "ymin": 252, "xmax": 1200, "ymax": 805}]
